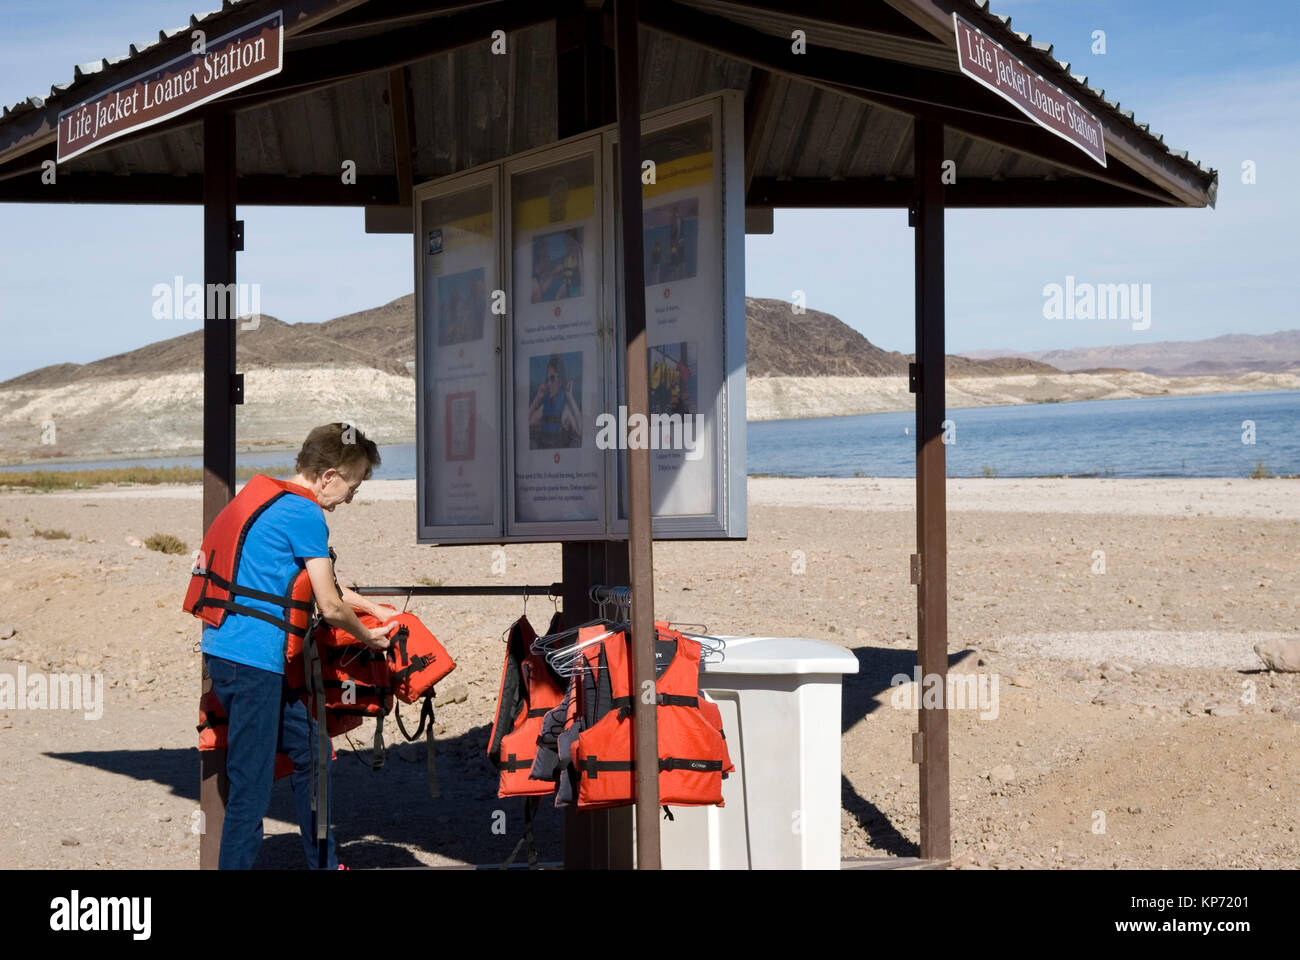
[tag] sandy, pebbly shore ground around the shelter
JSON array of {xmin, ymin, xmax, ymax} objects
[{"xmin": 0, "ymin": 479, "xmax": 1300, "ymax": 868}]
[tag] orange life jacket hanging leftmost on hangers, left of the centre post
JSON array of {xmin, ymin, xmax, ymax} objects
[{"xmin": 488, "ymin": 617, "xmax": 564, "ymax": 797}]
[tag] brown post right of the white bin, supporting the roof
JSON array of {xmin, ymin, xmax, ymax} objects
[{"xmin": 910, "ymin": 117, "xmax": 952, "ymax": 860}]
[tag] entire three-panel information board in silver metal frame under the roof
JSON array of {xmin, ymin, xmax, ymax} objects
[{"xmin": 415, "ymin": 91, "xmax": 746, "ymax": 544}]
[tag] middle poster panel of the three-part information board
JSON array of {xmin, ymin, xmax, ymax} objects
[{"xmin": 510, "ymin": 150, "xmax": 605, "ymax": 524}]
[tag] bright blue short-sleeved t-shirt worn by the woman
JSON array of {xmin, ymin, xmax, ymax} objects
[{"xmin": 203, "ymin": 493, "xmax": 329, "ymax": 674}]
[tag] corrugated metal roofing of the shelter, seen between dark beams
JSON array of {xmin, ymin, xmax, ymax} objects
[{"xmin": 0, "ymin": 0, "xmax": 1212, "ymax": 201}]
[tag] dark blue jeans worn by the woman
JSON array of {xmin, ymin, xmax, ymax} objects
[{"xmin": 203, "ymin": 654, "xmax": 338, "ymax": 870}]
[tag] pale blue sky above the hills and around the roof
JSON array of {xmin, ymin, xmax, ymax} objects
[{"xmin": 0, "ymin": 0, "xmax": 1300, "ymax": 380}]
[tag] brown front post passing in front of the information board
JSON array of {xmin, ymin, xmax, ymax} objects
[{"xmin": 614, "ymin": 0, "xmax": 660, "ymax": 870}]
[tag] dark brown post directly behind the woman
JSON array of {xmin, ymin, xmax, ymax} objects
[{"xmin": 199, "ymin": 113, "xmax": 239, "ymax": 870}]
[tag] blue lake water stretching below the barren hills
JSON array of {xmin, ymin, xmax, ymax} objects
[{"xmin": 0, "ymin": 390, "xmax": 1300, "ymax": 480}]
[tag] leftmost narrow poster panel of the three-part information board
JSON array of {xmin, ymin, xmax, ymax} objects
[{"xmin": 417, "ymin": 177, "xmax": 504, "ymax": 528}]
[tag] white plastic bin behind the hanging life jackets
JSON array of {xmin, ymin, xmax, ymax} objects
[{"xmin": 659, "ymin": 636, "xmax": 858, "ymax": 870}]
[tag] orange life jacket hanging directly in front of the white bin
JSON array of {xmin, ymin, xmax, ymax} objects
[{"xmin": 571, "ymin": 622, "xmax": 735, "ymax": 809}]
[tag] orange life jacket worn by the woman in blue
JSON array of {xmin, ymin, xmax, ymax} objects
[{"xmin": 182, "ymin": 473, "xmax": 316, "ymax": 637}]
